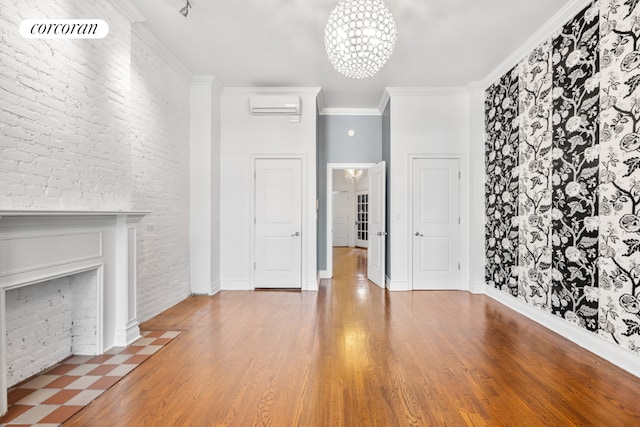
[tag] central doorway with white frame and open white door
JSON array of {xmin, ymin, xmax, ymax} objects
[{"xmin": 326, "ymin": 162, "xmax": 387, "ymax": 287}]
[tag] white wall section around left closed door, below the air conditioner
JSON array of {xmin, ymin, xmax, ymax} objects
[{"xmin": 220, "ymin": 88, "xmax": 318, "ymax": 290}]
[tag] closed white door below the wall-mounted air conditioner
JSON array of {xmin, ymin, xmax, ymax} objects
[{"xmin": 254, "ymin": 159, "xmax": 302, "ymax": 288}]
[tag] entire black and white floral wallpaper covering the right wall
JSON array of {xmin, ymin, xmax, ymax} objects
[{"xmin": 485, "ymin": 0, "xmax": 640, "ymax": 353}]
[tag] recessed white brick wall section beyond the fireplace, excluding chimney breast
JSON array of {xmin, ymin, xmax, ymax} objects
[{"xmin": 131, "ymin": 33, "xmax": 191, "ymax": 320}]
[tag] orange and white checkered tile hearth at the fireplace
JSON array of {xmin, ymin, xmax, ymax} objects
[{"xmin": 0, "ymin": 331, "xmax": 180, "ymax": 427}]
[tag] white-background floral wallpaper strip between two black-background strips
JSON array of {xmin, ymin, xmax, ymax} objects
[{"xmin": 518, "ymin": 42, "xmax": 553, "ymax": 311}]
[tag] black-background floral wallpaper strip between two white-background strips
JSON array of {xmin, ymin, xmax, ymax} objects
[{"xmin": 551, "ymin": 5, "xmax": 600, "ymax": 331}]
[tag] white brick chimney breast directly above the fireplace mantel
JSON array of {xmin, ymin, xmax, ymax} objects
[{"xmin": 0, "ymin": 0, "xmax": 131, "ymax": 209}]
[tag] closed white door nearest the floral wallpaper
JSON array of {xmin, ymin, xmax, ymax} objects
[{"xmin": 412, "ymin": 159, "xmax": 460, "ymax": 290}]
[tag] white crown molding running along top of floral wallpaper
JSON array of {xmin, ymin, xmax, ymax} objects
[{"xmin": 482, "ymin": 0, "xmax": 593, "ymax": 89}]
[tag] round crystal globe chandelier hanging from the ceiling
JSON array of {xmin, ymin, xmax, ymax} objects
[{"xmin": 324, "ymin": 0, "xmax": 396, "ymax": 79}]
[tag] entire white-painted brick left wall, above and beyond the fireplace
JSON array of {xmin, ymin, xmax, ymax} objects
[{"xmin": 0, "ymin": 0, "xmax": 191, "ymax": 321}]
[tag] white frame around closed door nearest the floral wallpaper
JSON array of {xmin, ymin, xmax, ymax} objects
[{"xmin": 407, "ymin": 153, "xmax": 467, "ymax": 291}]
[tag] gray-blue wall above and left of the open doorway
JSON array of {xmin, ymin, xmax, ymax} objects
[{"xmin": 318, "ymin": 116, "xmax": 382, "ymax": 270}]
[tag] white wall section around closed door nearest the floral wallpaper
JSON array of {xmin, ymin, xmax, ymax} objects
[{"xmin": 387, "ymin": 88, "xmax": 469, "ymax": 291}]
